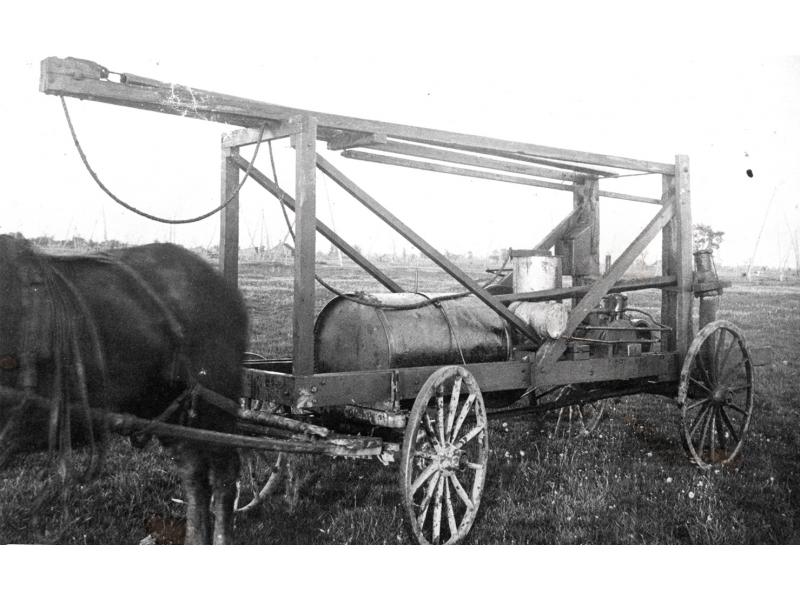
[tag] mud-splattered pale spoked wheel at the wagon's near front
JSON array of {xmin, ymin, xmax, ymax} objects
[{"xmin": 400, "ymin": 366, "xmax": 489, "ymax": 544}]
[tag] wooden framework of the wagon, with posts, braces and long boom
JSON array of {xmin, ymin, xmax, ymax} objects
[{"xmin": 41, "ymin": 58, "xmax": 768, "ymax": 548}]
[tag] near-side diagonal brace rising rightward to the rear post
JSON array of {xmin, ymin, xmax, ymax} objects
[{"xmin": 536, "ymin": 203, "xmax": 675, "ymax": 372}]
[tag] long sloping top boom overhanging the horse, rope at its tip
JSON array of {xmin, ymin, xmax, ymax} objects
[{"xmin": 39, "ymin": 57, "xmax": 674, "ymax": 174}]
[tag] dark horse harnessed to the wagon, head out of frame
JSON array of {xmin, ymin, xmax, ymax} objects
[{"xmin": 0, "ymin": 235, "xmax": 248, "ymax": 543}]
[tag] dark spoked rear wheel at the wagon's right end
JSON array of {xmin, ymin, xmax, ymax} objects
[{"xmin": 678, "ymin": 321, "xmax": 753, "ymax": 469}]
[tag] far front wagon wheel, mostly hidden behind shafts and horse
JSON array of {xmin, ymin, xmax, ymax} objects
[{"xmin": 234, "ymin": 400, "xmax": 286, "ymax": 513}]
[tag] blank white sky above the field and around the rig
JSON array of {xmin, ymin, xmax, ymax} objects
[{"xmin": 0, "ymin": 1, "xmax": 800, "ymax": 266}]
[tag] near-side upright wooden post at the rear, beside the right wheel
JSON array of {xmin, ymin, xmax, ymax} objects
[{"xmin": 675, "ymin": 155, "xmax": 694, "ymax": 357}]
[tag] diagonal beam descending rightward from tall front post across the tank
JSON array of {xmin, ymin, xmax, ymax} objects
[{"xmin": 317, "ymin": 155, "xmax": 541, "ymax": 344}]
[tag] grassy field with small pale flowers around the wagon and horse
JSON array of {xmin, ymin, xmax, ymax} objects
[{"xmin": 0, "ymin": 264, "xmax": 800, "ymax": 544}]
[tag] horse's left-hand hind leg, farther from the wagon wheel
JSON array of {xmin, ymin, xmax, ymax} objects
[{"xmin": 174, "ymin": 443, "xmax": 211, "ymax": 544}]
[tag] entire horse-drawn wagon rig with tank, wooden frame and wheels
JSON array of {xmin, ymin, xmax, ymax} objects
[{"xmin": 41, "ymin": 58, "xmax": 769, "ymax": 544}]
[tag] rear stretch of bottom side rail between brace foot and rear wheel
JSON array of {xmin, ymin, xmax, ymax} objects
[{"xmin": 533, "ymin": 353, "xmax": 679, "ymax": 388}]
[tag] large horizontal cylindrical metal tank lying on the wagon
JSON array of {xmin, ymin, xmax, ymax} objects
[{"xmin": 314, "ymin": 293, "xmax": 511, "ymax": 373}]
